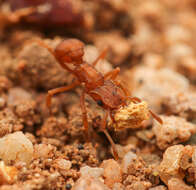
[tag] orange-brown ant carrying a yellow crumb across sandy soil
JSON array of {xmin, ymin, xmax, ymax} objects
[{"xmin": 35, "ymin": 39, "xmax": 162, "ymax": 159}]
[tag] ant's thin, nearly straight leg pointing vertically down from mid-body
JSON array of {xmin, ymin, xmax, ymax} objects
[{"xmin": 80, "ymin": 90, "xmax": 89, "ymax": 141}]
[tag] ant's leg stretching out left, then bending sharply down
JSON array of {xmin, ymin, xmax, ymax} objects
[{"xmin": 46, "ymin": 81, "xmax": 80, "ymax": 109}]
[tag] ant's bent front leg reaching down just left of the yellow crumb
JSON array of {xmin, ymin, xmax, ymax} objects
[{"xmin": 101, "ymin": 110, "xmax": 119, "ymax": 160}]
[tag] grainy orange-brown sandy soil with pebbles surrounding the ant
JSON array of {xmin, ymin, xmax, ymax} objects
[{"xmin": 0, "ymin": 0, "xmax": 196, "ymax": 190}]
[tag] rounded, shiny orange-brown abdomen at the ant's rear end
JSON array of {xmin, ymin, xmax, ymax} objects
[{"xmin": 55, "ymin": 39, "xmax": 84, "ymax": 64}]
